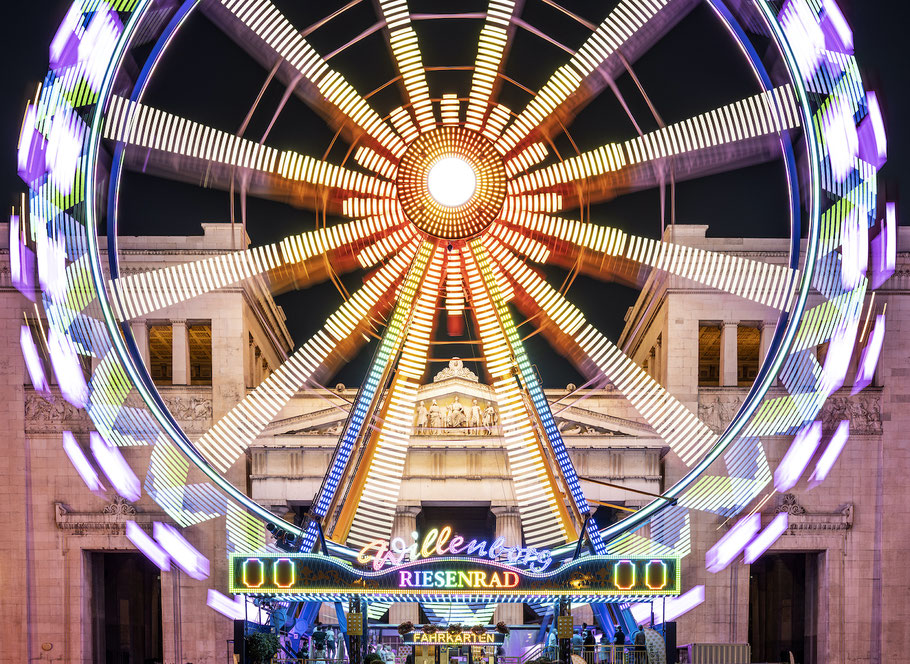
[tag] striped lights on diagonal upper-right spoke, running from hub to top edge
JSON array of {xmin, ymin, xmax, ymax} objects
[{"xmin": 497, "ymin": 0, "xmax": 668, "ymax": 154}]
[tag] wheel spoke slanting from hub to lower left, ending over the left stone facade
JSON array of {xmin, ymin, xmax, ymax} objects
[{"xmin": 196, "ymin": 240, "xmax": 418, "ymax": 472}]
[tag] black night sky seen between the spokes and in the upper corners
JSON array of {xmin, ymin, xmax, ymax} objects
[{"xmin": 0, "ymin": 0, "xmax": 910, "ymax": 387}]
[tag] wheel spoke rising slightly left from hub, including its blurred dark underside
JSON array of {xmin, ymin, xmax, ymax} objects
[{"xmin": 104, "ymin": 96, "xmax": 395, "ymax": 212}]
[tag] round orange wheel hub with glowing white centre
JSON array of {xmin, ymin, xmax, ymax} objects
[{"xmin": 397, "ymin": 125, "xmax": 506, "ymax": 240}]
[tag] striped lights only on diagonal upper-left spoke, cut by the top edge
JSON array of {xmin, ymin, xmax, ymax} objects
[{"xmin": 222, "ymin": 0, "xmax": 405, "ymax": 157}]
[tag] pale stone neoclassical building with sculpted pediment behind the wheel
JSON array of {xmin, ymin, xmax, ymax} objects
[{"xmin": 0, "ymin": 224, "xmax": 910, "ymax": 664}]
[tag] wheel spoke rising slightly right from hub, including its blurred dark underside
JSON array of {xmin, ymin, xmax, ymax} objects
[{"xmin": 509, "ymin": 84, "xmax": 800, "ymax": 203}]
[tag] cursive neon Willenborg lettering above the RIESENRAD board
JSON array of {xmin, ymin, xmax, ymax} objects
[{"xmin": 357, "ymin": 526, "xmax": 553, "ymax": 572}]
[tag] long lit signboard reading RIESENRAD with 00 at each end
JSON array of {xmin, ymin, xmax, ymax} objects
[{"xmin": 230, "ymin": 554, "xmax": 680, "ymax": 602}]
